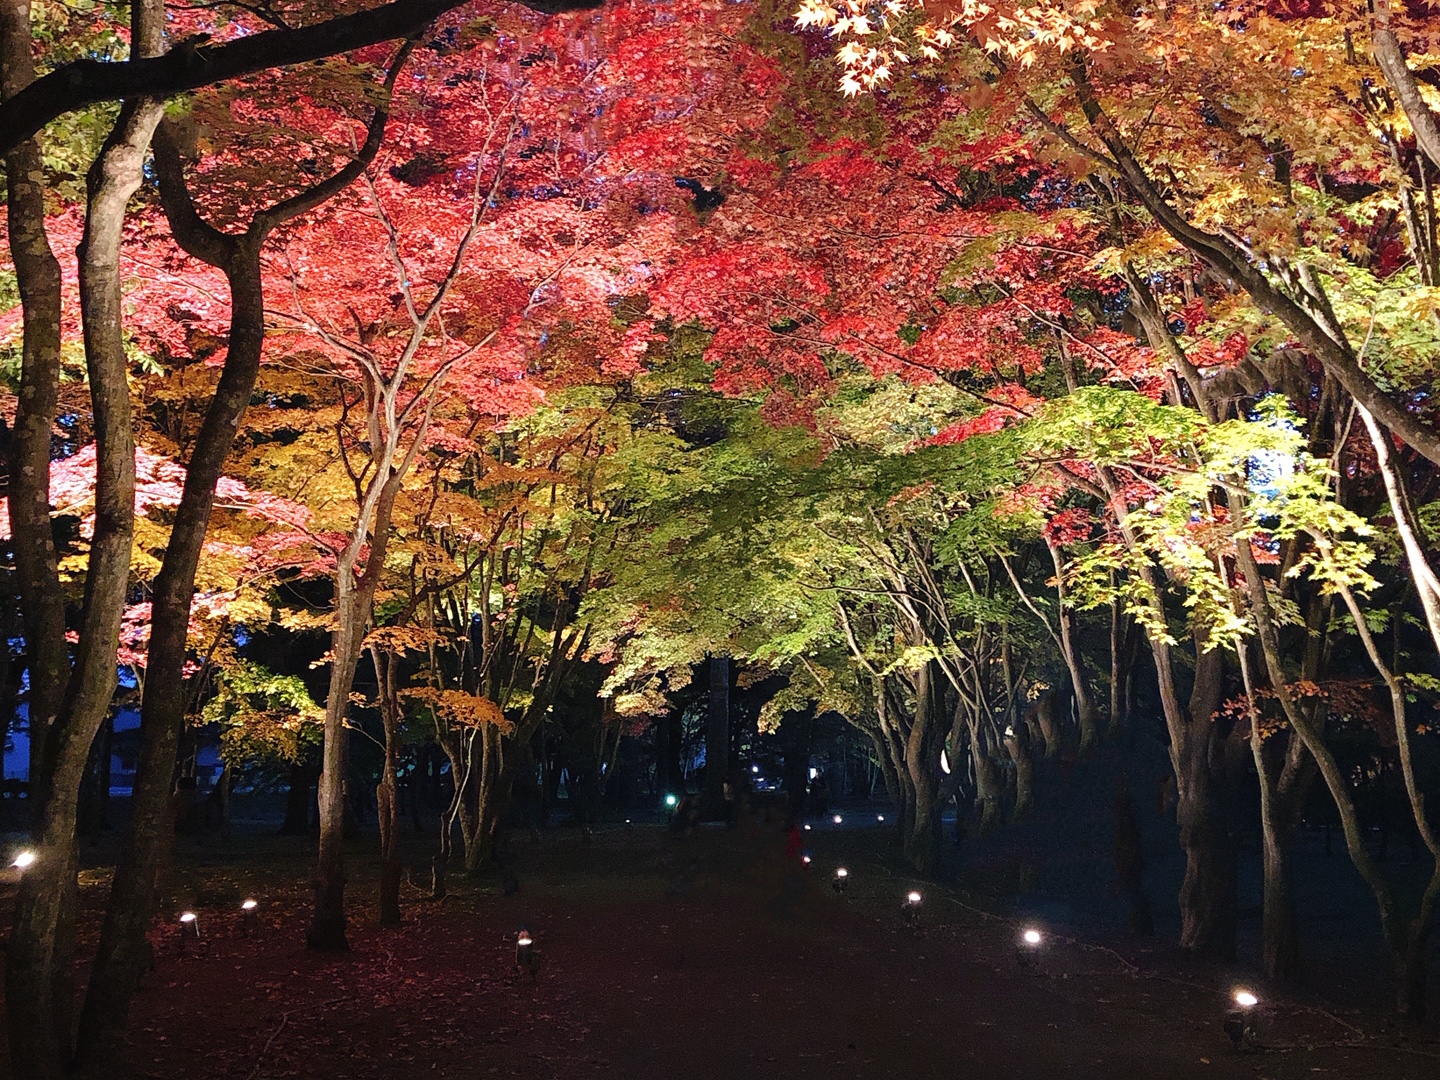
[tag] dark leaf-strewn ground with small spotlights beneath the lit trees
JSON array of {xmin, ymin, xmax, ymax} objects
[{"xmin": 0, "ymin": 825, "xmax": 1440, "ymax": 1080}]
